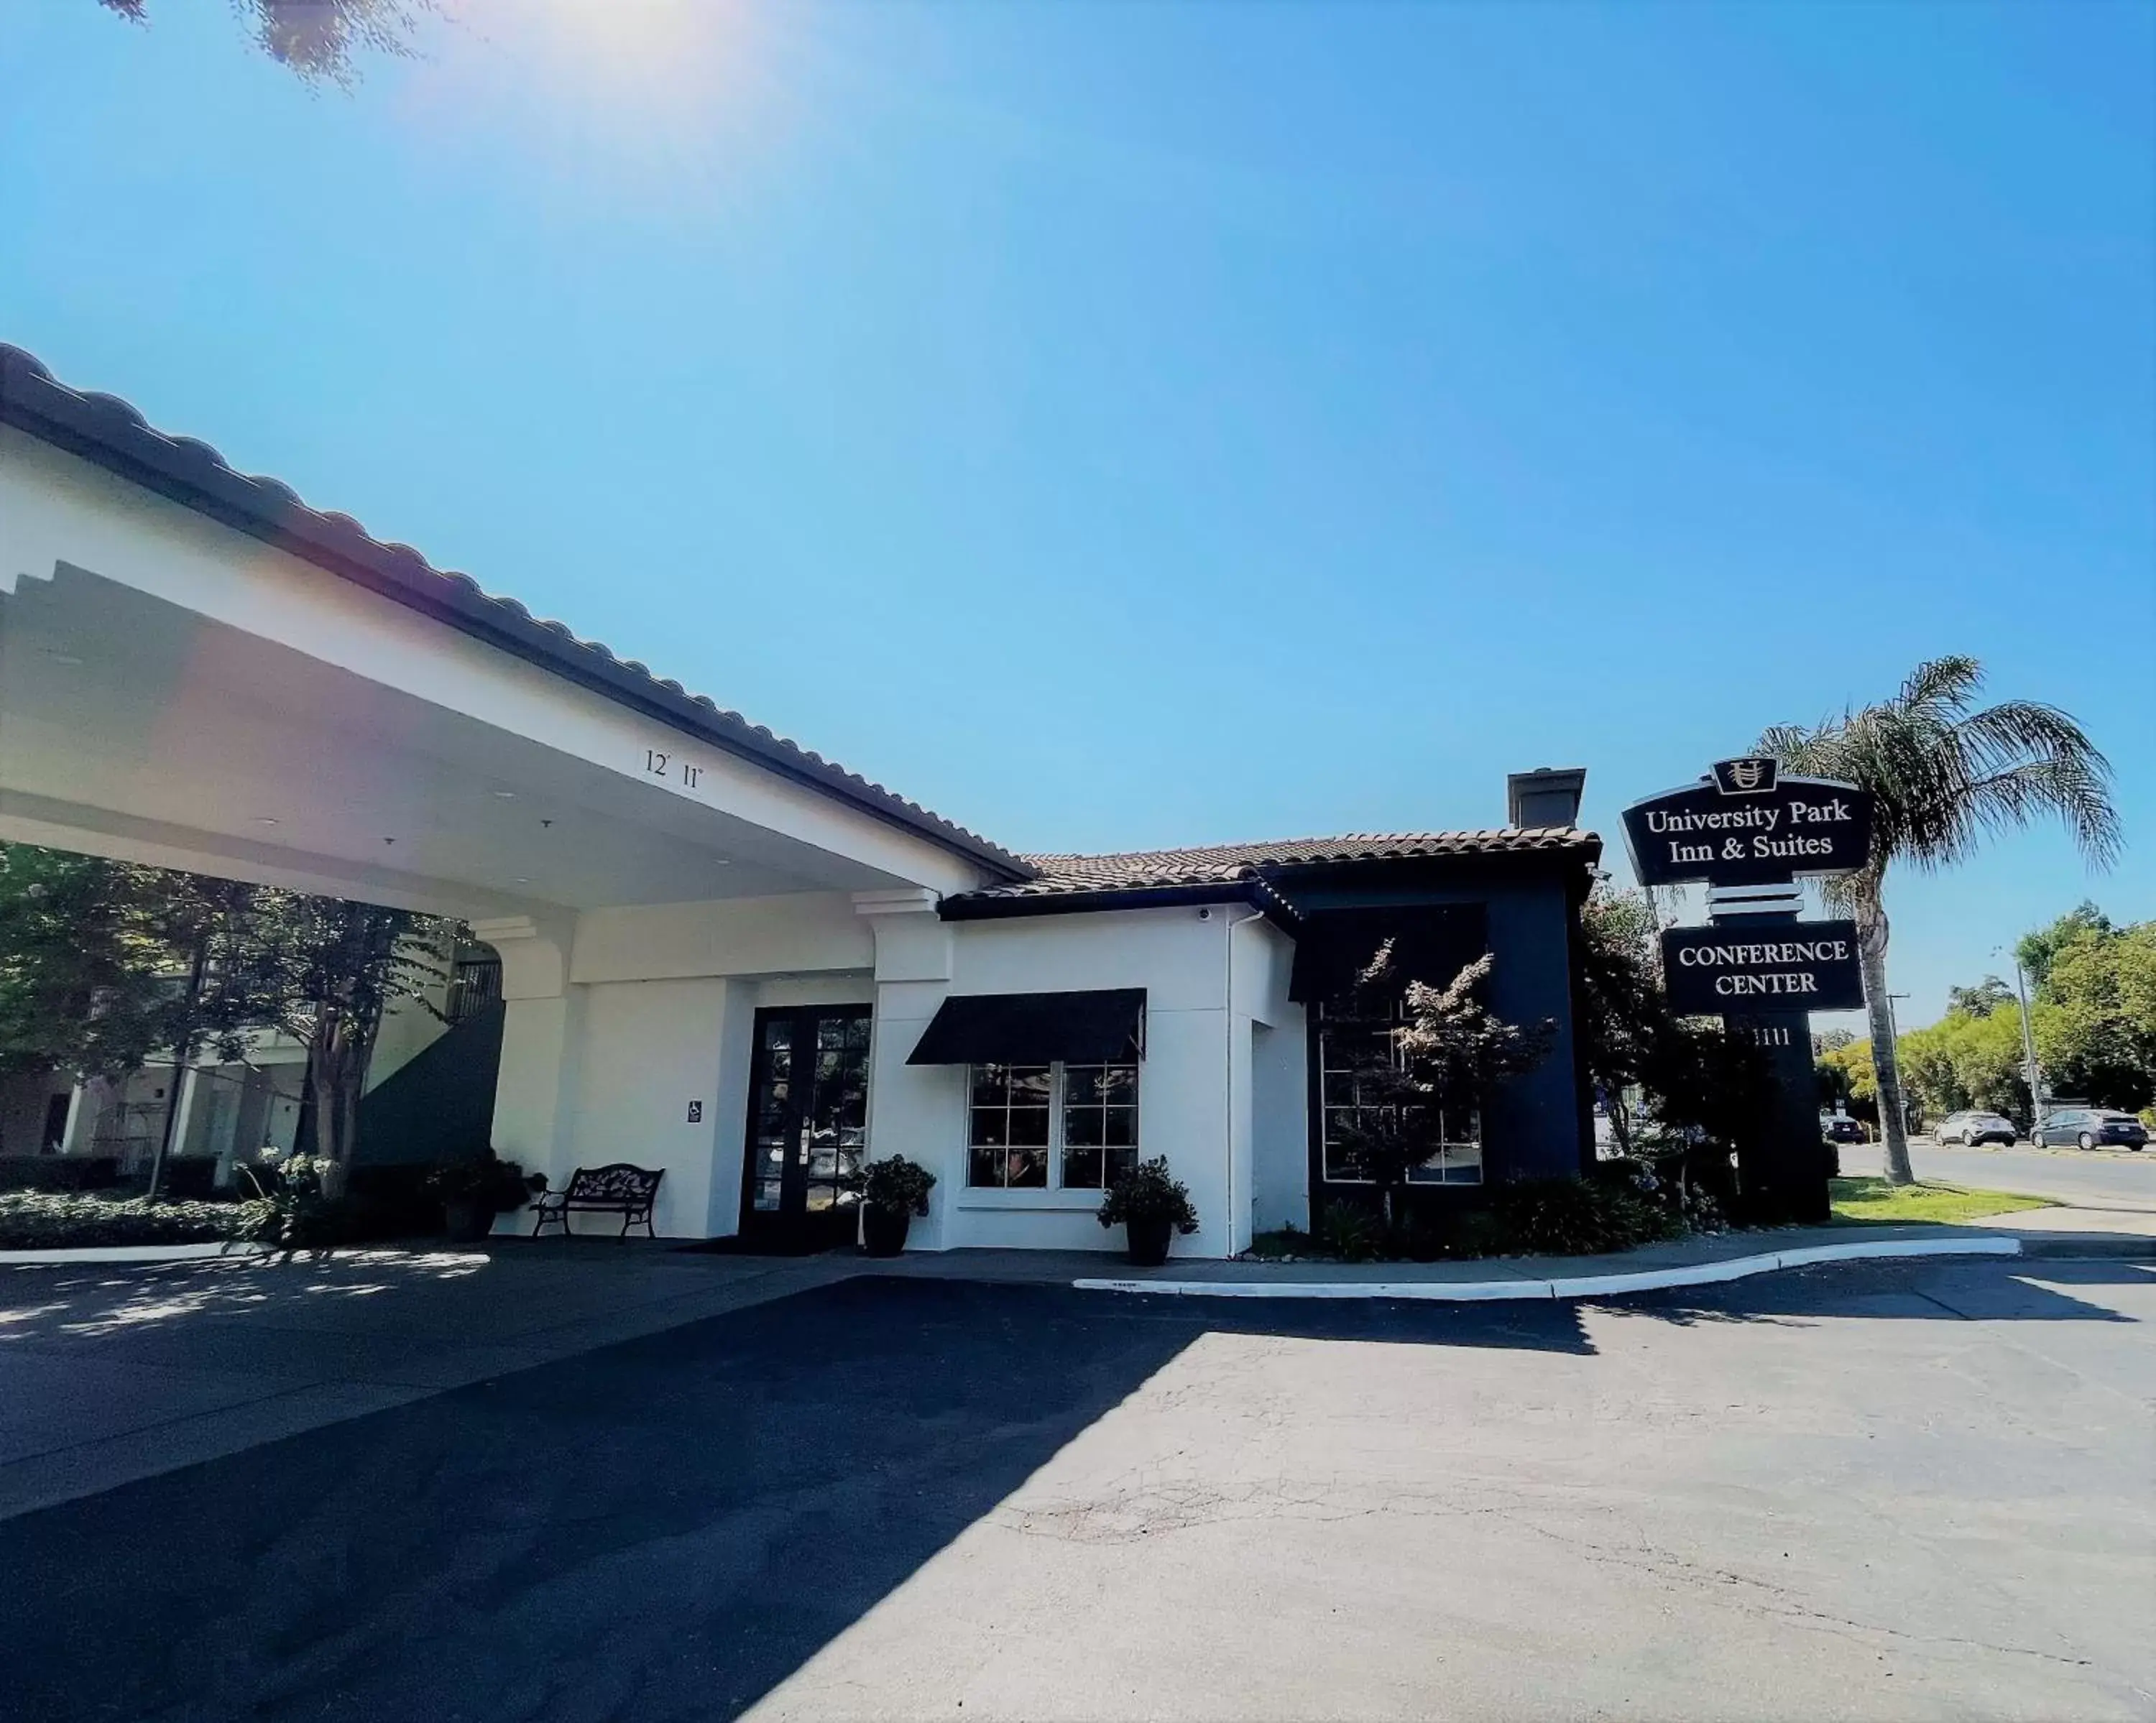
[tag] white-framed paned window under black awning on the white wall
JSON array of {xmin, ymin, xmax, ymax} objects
[{"xmin": 966, "ymin": 1061, "xmax": 1138, "ymax": 1191}]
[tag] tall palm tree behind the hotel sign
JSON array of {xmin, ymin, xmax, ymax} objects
[{"xmin": 1759, "ymin": 657, "xmax": 2119, "ymax": 1184}]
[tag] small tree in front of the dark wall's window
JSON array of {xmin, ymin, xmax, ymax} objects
[{"xmin": 1339, "ymin": 941, "xmax": 1557, "ymax": 1232}]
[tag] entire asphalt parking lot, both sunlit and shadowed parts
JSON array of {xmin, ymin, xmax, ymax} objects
[{"xmin": 0, "ymin": 1262, "xmax": 2156, "ymax": 1723}]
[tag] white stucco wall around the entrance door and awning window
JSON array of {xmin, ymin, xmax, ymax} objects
[{"xmin": 483, "ymin": 893, "xmax": 1307, "ymax": 1255}]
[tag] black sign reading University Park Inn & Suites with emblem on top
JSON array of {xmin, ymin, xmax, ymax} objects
[{"xmin": 1623, "ymin": 759, "xmax": 1871, "ymax": 887}]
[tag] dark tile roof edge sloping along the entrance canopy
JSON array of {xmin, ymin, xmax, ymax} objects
[{"xmin": 0, "ymin": 343, "xmax": 1033, "ymax": 880}]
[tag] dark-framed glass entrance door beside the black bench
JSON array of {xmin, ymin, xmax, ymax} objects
[{"xmin": 742, "ymin": 1005, "xmax": 869, "ymax": 1251}]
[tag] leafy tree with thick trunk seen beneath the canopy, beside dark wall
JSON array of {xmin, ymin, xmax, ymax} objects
[{"xmin": 209, "ymin": 889, "xmax": 457, "ymax": 1197}]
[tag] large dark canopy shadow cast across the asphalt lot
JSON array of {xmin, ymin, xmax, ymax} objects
[{"xmin": 0, "ymin": 1279, "xmax": 1589, "ymax": 1723}]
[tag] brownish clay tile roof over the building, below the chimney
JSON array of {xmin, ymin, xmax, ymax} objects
[{"xmin": 968, "ymin": 826, "xmax": 1602, "ymax": 900}]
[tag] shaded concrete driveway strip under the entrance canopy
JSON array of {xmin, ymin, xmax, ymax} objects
[{"xmin": 0, "ymin": 1240, "xmax": 849, "ymax": 1518}]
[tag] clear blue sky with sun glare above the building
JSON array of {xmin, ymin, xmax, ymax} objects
[{"xmin": 0, "ymin": 0, "xmax": 2156, "ymax": 1022}]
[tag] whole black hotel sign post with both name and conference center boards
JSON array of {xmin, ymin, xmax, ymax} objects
[{"xmin": 1623, "ymin": 759, "xmax": 1871, "ymax": 1221}]
